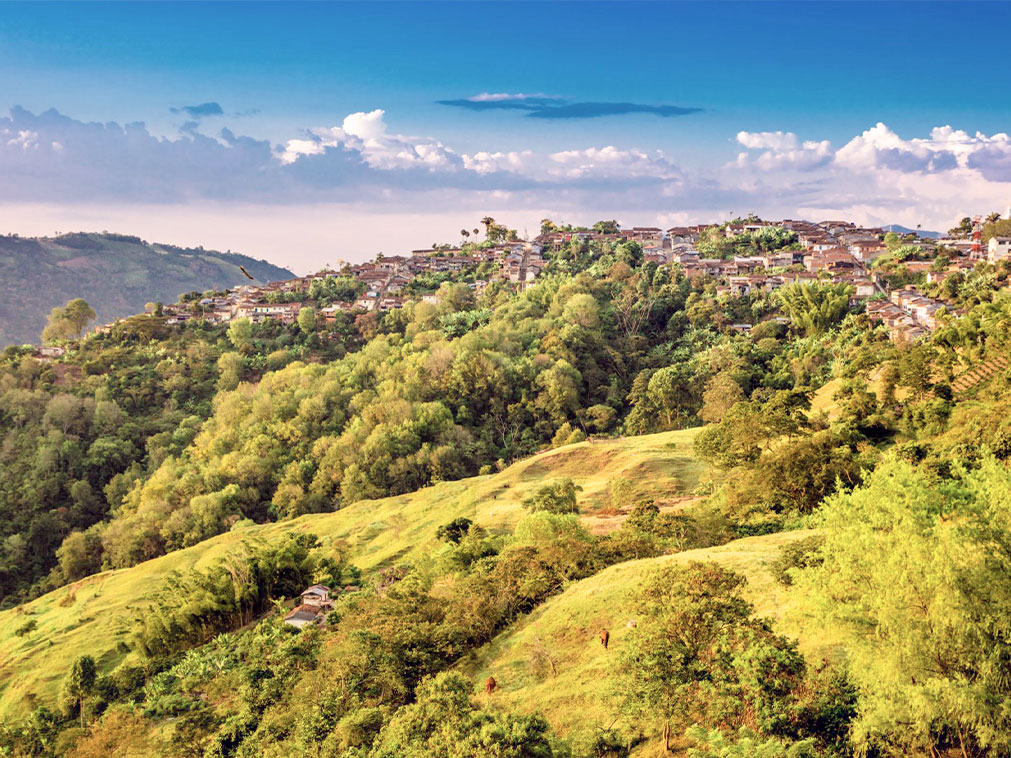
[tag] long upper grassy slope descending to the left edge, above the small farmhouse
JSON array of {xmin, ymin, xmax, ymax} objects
[{"xmin": 0, "ymin": 430, "xmax": 703, "ymax": 718}]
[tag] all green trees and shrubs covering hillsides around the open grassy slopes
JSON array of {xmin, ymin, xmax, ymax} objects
[{"xmin": 0, "ymin": 228, "xmax": 1011, "ymax": 758}]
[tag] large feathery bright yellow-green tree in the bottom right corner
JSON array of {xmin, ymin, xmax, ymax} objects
[{"xmin": 795, "ymin": 457, "xmax": 1011, "ymax": 756}]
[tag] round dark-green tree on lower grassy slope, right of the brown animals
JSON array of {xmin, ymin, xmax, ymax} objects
[{"xmin": 618, "ymin": 561, "xmax": 804, "ymax": 749}]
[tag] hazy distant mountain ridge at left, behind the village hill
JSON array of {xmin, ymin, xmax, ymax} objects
[{"xmin": 0, "ymin": 232, "xmax": 294, "ymax": 348}]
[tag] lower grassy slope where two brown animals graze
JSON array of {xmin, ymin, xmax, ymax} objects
[{"xmin": 460, "ymin": 532, "xmax": 835, "ymax": 753}]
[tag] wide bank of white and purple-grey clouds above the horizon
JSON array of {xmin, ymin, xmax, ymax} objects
[{"xmin": 0, "ymin": 103, "xmax": 1011, "ymax": 270}]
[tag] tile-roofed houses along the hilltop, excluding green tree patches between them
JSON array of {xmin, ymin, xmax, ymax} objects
[{"xmin": 76, "ymin": 218, "xmax": 1011, "ymax": 340}]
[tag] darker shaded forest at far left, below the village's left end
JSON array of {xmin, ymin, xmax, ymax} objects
[{"xmin": 0, "ymin": 315, "xmax": 364, "ymax": 606}]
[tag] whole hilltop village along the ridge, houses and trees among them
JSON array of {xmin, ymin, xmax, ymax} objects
[{"xmin": 84, "ymin": 216, "xmax": 1011, "ymax": 342}]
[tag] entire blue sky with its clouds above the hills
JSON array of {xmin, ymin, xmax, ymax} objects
[{"xmin": 0, "ymin": 2, "xmax": 1011, "ymax": 266}]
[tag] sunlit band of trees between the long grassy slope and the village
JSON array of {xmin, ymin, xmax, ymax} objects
[{"xmin": 75, "ymin": 250, "xmax": 842, "ymax": 567}]
